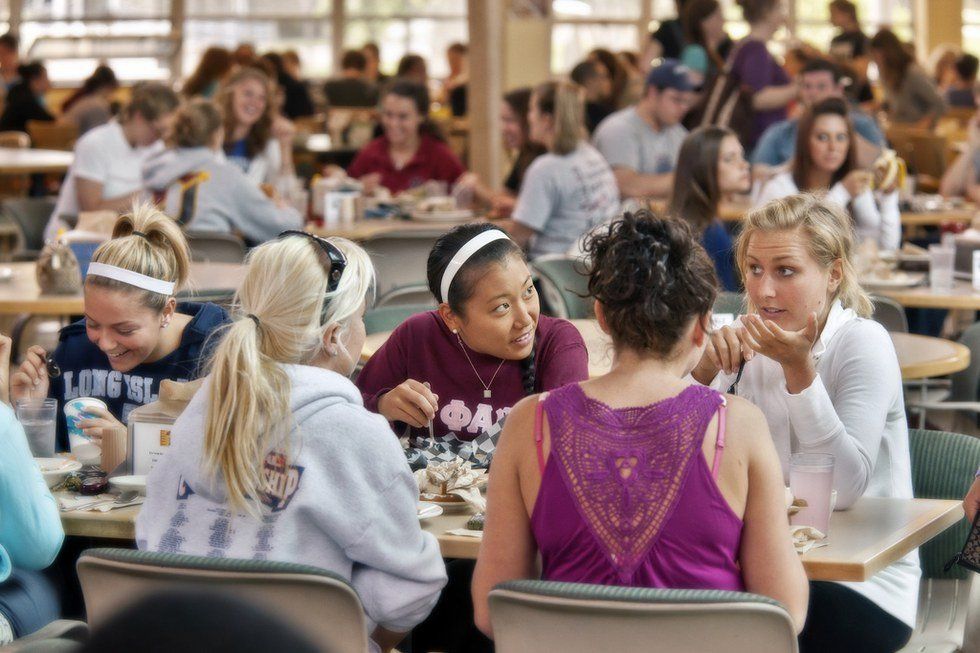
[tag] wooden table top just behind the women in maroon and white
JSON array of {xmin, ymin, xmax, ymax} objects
[{"xmin": 361, "ymin": 320, "xmax": 970, "ymax": 380}]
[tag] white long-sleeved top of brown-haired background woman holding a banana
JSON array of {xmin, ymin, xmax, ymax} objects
[{"xmin": 753, "ymin": 172, "xmax": 902, "ymax": 251}]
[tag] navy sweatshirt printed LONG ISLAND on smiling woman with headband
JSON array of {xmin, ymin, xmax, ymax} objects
[{"xmin": 48, "ymin": 302, "xmax": 228, "ymax": 451}]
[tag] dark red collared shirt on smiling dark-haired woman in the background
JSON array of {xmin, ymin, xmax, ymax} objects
[{"xmin": 347, "ymin": 134, "xmax": 466, "ymax": 194}]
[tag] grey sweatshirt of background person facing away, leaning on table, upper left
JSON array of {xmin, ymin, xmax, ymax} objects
[{"xmin": 143, "ymin": 147, "xmax": 303, "ymax": 243}]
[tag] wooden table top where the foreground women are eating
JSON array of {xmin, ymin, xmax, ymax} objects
[{"xmin": 61, "ymin": 497, "xmax": 963, "ymax": 581}]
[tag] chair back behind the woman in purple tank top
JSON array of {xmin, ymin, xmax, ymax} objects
[{"xmin": 490, "ymin": 580, "xmax": 797, "ymax": 653}]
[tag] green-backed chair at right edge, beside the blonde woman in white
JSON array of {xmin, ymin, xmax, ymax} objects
[{"xmin": 902, "ymin": 429, "xmax": 980, "ymax": 653}]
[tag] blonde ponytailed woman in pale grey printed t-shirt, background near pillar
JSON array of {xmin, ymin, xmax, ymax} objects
[{"xmin": 508, "ymin": 82, "xmax": 619, "ymax": 258}]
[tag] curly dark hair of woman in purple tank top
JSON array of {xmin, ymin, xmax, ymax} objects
[{"xmin": 585, "ymin": 209, "xmax": 718, "ymax": 357}]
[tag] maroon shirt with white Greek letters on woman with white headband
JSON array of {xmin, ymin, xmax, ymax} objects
[{"xmin": 357, "ymin": 311, "xmax": 589, "ymax": 440}]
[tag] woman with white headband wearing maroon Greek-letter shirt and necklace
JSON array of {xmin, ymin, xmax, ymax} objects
[{"xmin": 357, "ymin": 224, "xmax": 588, "ymax": 440}]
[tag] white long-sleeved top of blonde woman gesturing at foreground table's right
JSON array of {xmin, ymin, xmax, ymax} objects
[{"xmin": 711, "ymin": 300, "xmax": 920, "ymax": 628}]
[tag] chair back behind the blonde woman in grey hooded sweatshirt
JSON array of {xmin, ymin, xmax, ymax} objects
[{"xmin": 77, "ymin": 549, "xmax": 368, "ymax": 653}]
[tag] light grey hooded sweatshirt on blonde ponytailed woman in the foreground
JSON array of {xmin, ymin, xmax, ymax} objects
[{"xmin": 136, "ymin": 365, "xmax": 446, "ymax": 632}]
